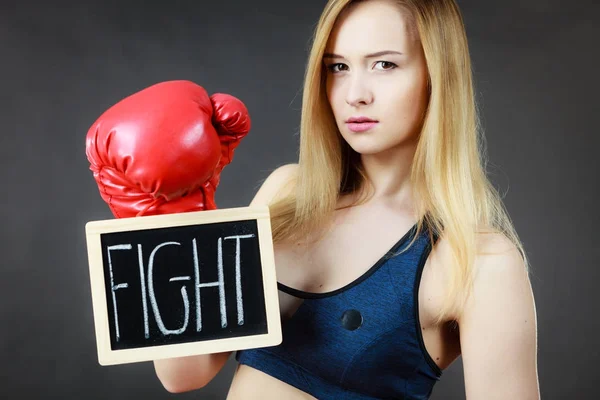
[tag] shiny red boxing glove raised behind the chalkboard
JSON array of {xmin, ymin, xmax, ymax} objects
[{"xmin": 86, "ymin": 81, "xmax": 250, "ymax": 218}]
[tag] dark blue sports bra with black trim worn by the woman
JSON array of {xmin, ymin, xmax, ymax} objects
[{"xmin": 236, "ymin": 224, "xmax": 442, "ymax": 400}]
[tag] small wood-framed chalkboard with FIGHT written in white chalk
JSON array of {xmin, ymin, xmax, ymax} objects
[{"xmin": 86, "ymin": 206, "xmax": 281, "ymax": 365}]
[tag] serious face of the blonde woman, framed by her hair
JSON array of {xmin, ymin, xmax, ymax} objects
[{"xmin": 323, "ymin": 0, "xmax": 427, "ymax": 155}]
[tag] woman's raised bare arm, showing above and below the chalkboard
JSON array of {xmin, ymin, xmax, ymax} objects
[{"xmin": 154, "ymin": 164, "xmax": 296, "ymax": 393}]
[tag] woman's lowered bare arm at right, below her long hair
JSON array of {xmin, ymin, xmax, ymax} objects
[{"xmin": 459, "ymin": 235, "xmax": 540, "ymax": 400}]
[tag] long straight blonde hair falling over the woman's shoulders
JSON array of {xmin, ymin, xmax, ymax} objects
[{"xmin": 270, "ymin": 0, "xmax": 529, "ymax": 322}]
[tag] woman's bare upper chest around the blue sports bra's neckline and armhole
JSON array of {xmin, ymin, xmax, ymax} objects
[{"xmin": 275, "ymin": 209, "xmax": 444, "ymax": 326}]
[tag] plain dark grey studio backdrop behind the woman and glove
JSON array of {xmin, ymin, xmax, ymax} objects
[{"xmin": 0, "ymin": 0, "xmax": 600, "ymax": 400}]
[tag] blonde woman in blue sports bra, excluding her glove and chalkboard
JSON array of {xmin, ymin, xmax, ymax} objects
[{"xmin": 155, "ymin": 0, "xmax": 539, "ymax": 399}]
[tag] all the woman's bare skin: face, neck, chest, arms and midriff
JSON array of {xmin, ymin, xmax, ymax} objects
[{"xmin": 155, "ymin": 0, "xmax": 539, "ymax": 400}]
